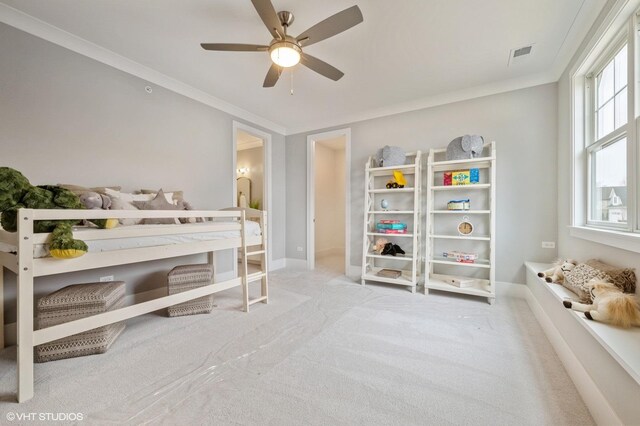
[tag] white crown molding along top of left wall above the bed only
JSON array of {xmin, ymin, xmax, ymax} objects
[{"xmin": 0, "ymin": 3, "xmax": 287, "ymax": 135}]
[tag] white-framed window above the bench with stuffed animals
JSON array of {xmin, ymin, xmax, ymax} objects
[{"xmin": 571, "ymin": 9, "xmax": 640, "ymax": 243}]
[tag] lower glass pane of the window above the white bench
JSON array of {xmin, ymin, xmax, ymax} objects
[{"xmin": 591, "ymin": 138, "xmax": 627, "ymax": 224}]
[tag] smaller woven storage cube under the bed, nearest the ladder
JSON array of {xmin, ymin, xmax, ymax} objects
[{"xmin": 167, "ymin": 264, "xmax": 213, "ymax": 317}]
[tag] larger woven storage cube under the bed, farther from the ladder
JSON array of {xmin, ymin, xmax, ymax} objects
[{"xmin": 35, "ymin": 281, "xmax": 125, "ymax": 362}]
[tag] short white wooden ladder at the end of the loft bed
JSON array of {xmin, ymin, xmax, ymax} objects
[{"xmin": 241, "ymin": 211, "xmax": 269, "ymax": 312}]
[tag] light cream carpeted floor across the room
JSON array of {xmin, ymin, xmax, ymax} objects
[{"xmin": 0, "ymin": 266, "xmax": 594, "ymax": 426}]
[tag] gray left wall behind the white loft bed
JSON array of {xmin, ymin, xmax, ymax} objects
[{"xmin": 0, "ymin": 24, "xmax": 285, "ymax": 318}]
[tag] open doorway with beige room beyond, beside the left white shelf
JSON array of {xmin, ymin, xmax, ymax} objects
[{"xmin": 307, "ymin": 129, "xmax": 351, "ymax": 274}]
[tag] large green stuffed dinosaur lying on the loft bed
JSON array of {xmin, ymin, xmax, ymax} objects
[{"xmin": 0, "ymin": 167, "xmax": 104, "ymax": 259}]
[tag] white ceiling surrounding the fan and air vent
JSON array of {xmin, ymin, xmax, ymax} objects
[{"xmin": 0, "ymin": 0, "xmax": 605, "ymax": 134}]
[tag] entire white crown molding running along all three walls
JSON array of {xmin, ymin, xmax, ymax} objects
[{"xmin": 0, "ymin": 0, "xmax": 604, "ymax": 136}]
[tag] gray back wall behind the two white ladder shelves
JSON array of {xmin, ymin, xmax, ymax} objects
[{"xmin": 286, "ymin": 84, "xmax": 557, "ymax": 283}]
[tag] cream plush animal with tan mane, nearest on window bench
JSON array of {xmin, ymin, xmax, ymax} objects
[{"xmin": 562, "ymin": 281, "xmax": 640, "ymax": 328}]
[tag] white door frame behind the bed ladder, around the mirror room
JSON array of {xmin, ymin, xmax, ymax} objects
[{"xmin": 231, "ymin": 120, "xmax": 273, "ymax": 276}]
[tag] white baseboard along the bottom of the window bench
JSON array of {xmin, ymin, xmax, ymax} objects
[{"xmin": 523, "ymin": 286, "xmax": 623, "ymax": 425}]
